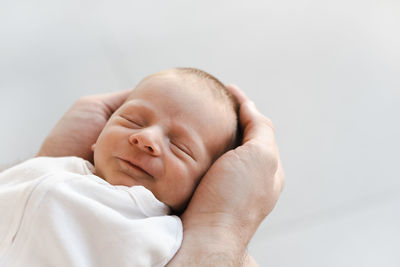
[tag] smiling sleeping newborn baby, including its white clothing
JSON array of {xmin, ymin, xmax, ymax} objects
[{"xmin": 0, "ymin": 68, "xmax": 238, "ymax": 266}]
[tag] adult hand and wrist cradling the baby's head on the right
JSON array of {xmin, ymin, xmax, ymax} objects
[{"xmin": 169, "ymin": 85, "xmax": 284, "ymax": 266}]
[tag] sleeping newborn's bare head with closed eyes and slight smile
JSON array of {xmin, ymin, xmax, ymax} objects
[{"xmin": 93, "ymin": 68, "xmax": 238, "ymax": 214}]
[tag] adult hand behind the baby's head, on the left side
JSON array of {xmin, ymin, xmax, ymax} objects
[{"xmin": 37, "ymin": 90, "xmax": 131, "ymax": 162}]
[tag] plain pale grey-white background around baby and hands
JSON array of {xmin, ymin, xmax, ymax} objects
[{"xmin": 0, "ymin": 0, "xmax": 400, "ymax": 267}]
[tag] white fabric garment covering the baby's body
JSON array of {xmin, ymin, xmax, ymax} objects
[{"xmin": 0, "ymin": 157, "xmax": 182, "ymax": 267}]
